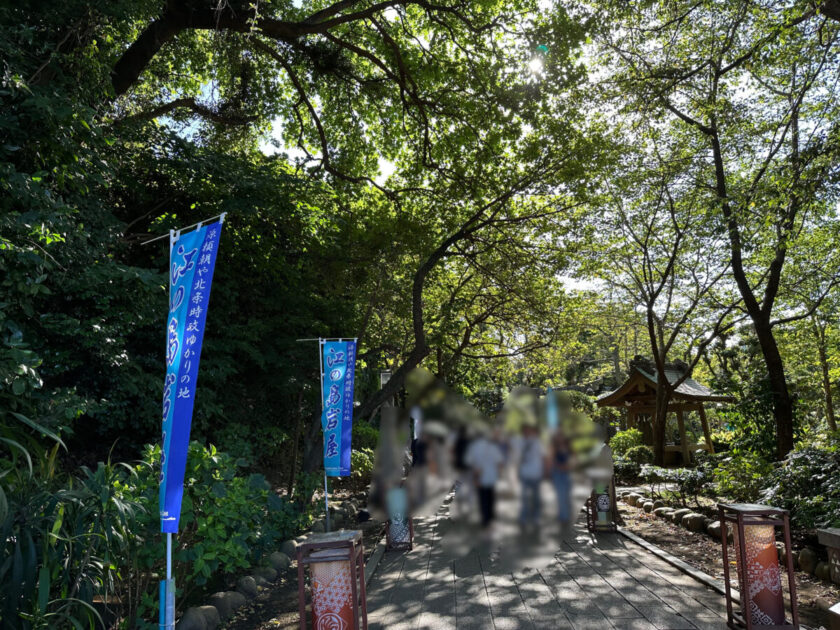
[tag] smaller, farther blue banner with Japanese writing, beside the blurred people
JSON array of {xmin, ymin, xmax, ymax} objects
[{"xmin": 321, "ymin": 341, "xmax": 356, "ymax": 477}]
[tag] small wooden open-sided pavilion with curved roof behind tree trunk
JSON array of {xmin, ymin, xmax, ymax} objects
[{"xmin": 596, "ymin": 357, "xmax": 734, "ymax": 464}]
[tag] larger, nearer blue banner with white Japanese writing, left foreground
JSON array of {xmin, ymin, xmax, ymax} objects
[{"xmin": 160, "ymin": 222, "xmax": 222, "ymax": 534}]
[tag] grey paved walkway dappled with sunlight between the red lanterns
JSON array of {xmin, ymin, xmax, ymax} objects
[{"xmin": 368, "ymin": 488, "xmax": 726, "ymax": 630}]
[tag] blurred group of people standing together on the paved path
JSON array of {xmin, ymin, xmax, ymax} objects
[{"xmin": 440, "ymin": 425, "xmax": 572, "ymax": 529}]
